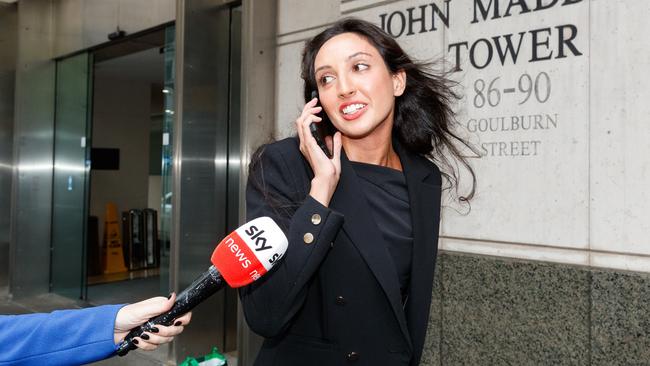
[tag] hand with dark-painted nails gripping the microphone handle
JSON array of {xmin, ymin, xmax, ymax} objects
[{"xmin": 114, "ymin": 294, "xmax": 192, "ymax": 351}]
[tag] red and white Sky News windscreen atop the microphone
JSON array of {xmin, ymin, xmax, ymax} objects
[{"xmin": 211, "ymin": 217, "xmax": 289, "ymax": 288}]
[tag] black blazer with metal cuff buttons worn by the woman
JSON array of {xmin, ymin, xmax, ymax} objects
[{"xmin": 240, "ymin": 137, "xmax": 441, "ymax": 366}]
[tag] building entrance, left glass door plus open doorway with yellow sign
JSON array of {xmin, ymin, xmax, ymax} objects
[{"xmin": 51, "ymin": 25, "xmax": 175, "ymax": 304}]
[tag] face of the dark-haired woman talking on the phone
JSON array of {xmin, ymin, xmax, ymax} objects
[{"xmin": 314, "ymin": 33, "xmax": 406, "ymax": 138}]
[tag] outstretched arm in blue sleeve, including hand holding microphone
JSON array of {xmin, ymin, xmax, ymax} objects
[{"xmin": 0, "ymin": 296, "xmax": 191, "ymax": 365}]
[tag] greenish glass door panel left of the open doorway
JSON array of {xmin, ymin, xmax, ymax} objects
[{"xmin": 50, "ymin": 53, "xmax": 92, "ymax": 298}]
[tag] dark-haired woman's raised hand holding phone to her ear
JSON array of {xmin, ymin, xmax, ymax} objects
[{"xmin": 296, "ymin": 98, "xmax": 341, "ymax": 206}]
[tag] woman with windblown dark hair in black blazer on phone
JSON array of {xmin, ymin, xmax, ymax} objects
[{"xmin": 240, "ymin": 19, "xmax": 475, "ymax": 366}]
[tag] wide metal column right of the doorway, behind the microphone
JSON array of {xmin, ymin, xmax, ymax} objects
[{"xmin": 170, "ymin": 0, "xmax": 239, "ymax": 361}]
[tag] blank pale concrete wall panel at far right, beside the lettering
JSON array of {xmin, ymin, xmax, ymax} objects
[{"xmin": 589, "ymin": 0, "xmax": 650, "ymax": 258}]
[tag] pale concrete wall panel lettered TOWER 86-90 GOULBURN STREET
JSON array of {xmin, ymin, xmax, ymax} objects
[{"xmin": 442, "ymin": 1, "xmax": 589, "ymax": 248}]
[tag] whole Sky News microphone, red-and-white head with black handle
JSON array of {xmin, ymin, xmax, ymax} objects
[{"xmin": 117, "ymin": 217, "xmax": 289, "ymax": 356}]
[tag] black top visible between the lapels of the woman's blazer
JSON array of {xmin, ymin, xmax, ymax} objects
[{"xmin": 350, "ymin": 161, "xmax": 413, "ymax": 302}]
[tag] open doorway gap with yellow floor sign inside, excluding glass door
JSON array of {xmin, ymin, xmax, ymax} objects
[{"xmin": 86, "ymin": 26, "xmax": 174, "ymax": 303}]
